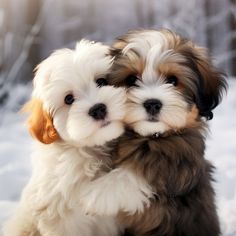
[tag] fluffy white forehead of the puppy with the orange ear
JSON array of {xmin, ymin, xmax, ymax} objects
[{"xmin": 34, "ymin": 40, "xmax": 112, "ymax": 87}]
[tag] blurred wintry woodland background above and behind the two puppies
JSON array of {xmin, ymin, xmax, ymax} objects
[{"xmin": 0, "ymin": 0, "xmax": 236, "ymax": 105}]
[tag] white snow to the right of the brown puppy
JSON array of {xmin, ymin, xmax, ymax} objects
[{"xmin": 206, "ymin": 79, "xmax": 236, "ymax": 236}]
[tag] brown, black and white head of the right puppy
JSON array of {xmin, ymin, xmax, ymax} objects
[{"xmin": 109, "ymin": 30, "xmax": 226, "ymax": 136}]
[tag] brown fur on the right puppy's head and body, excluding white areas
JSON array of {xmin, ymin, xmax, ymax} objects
[{"xmin": 109, "ymin": 30, "xmax": 226, "ymax": 236}]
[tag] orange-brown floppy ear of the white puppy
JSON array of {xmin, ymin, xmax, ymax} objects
[{"xmin": 22, "ymin": 99, "xmax": 59, "ymax": 144}]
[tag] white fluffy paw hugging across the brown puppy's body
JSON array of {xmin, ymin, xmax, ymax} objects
[{"xmin": 80, "ymin": 169, "xmax": 153, "ymax": 216}]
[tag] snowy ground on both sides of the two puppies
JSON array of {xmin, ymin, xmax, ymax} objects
[{"xmin": 0, "ymin": 80, "xmax": 236, "ymax": 236}]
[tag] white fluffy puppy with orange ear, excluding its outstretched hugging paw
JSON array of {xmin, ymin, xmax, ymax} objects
[{"xmin": 4, "ymin": 40, "xmax": 126, "ymax": 236}]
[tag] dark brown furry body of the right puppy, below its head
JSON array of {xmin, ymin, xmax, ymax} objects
[{"xmin": 115, "ymin": 128, "xmax": 220, "ymax": 236}]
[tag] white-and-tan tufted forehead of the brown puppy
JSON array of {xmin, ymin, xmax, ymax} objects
[{"xmin": 118, "ymin": 30, "xmax": 186, "ymax": 80}]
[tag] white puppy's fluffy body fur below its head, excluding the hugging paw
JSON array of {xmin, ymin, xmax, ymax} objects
[{"xmin": 4, "ymin": 144, "xmax": 123, "ymax": 236}]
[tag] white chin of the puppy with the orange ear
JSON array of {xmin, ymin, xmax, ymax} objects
[{"xmin": 77, "ymin": 121, "xmax": 124, "ymax": 146}]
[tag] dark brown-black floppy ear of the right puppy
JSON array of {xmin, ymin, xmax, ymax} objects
[{"xmin": 194, "ymin": 47, "xmax": 227, "ymax": 120}]
